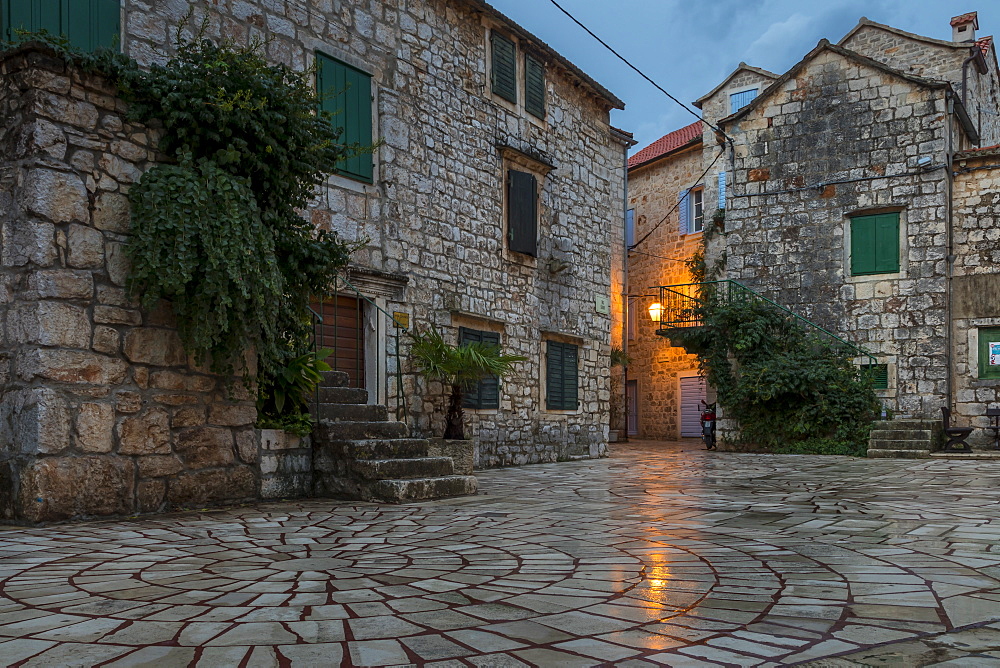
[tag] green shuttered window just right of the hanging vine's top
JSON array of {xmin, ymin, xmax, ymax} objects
[{"xmin": 316, "ymin": 52, "xmax": 373, "ymax": 183}]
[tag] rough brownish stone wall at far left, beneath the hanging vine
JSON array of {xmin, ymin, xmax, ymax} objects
[{"xmin": 0, "ymin": 46, "xmax": 259, "ymax": 521}]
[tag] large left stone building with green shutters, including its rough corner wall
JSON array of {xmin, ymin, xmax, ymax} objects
[{"xmin": 0, "ymin": 0, "xmax": 631, "ymax": 516}]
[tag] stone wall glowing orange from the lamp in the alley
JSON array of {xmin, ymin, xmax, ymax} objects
[{"xmin": 628, "ymin": 145, "xmax": 714, "ymax": 439}]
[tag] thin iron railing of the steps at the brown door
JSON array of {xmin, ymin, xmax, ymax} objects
[{"xmin": 309, "ymin": 276, "xmax": 409, "ymax": 422}]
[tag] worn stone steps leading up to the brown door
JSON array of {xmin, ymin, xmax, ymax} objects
[{"xmin": 313, "ymin": 371, "xmax": 478, "ymax": 503}]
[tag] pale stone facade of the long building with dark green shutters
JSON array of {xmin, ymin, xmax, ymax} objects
[{"xmin": 117, "ymin": 0, "xmax": 624, "ymax": 466}]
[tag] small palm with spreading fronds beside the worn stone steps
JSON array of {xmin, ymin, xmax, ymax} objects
[{"xmin": 410, "ymin": 327, "xmax": 527, "ymax": 440}]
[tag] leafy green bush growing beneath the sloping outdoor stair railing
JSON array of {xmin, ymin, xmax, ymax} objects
[{"xmin": 670, "ymin": 209, "xmax": 880, "ymax": 456}]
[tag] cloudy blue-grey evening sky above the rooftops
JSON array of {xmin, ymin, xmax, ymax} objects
[{"xmin": 489, "ymin": 0, "xmax": 988, "ymax": 150}]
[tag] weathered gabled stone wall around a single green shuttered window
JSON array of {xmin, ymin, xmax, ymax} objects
[{"xmin": 726, "ymin": 50, "xmax": 948, "ymax": 417}]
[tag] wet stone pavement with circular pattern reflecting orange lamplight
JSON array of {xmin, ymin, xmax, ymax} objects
[{"xmin": 0, "ymin": 442, "xmax": 1000, "ymax": 668}]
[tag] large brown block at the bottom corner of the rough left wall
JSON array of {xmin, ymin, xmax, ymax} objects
[{"xmin": 19, "ymin": 455, "xmax": 134, "ymax": 522}]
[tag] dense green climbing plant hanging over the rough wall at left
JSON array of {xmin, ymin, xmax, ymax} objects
[{"xmin": 14, "ymin": 29, "xmax": 371, "ymax": 379}]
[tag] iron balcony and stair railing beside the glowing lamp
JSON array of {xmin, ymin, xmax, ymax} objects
[{"xmin": 651, "ymin": 279, "xmax": 877, "ymax": 366}]
